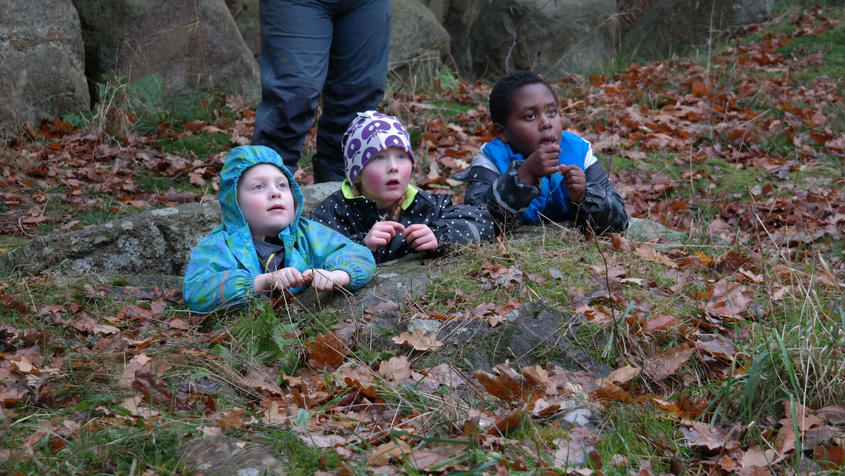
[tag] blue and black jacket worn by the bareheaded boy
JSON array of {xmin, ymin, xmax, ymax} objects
[{"xmin": 456, "ymin": 131, "xmax": 628, "ymax": 233}]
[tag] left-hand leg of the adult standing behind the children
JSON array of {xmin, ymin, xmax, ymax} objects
[{"xmin": 252, "ymin": 0, "xmax": 332, "ymax": 172}]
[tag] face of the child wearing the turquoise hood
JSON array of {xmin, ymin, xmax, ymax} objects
[{"xmin": 238, "ymin": 164, "xmax": 296, "ymax": 237}]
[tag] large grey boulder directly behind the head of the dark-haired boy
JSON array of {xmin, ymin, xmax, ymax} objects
[{"xmin": 463, "ymin": 0, "xmax": 617, "ymax": 80}]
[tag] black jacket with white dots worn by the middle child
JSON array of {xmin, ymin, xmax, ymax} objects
[{"xmin": 311, "ymin": 180, "xmax": 494, "ymax": 263}]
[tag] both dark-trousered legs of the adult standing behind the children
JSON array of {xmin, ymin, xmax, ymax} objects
[{"xmin": 252, "ymin": 0, "xmax": 391, "ymax": 182}]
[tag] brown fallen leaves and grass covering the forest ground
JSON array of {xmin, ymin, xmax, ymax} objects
[{"xmin": 0, "ymin": 4, "xmax": 845, "ymax": 474}]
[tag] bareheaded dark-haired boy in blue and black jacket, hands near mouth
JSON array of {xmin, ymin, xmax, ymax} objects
[{"xmin": 460, "ymin": 71, "xmax": 628, "ymax": 233}]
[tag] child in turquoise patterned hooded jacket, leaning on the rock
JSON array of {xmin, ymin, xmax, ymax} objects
[{"xmin": 183, "ymin": 146, "xmax": 375, "ymax": 312}]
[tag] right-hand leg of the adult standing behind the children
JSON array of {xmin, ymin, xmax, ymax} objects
[{"xmin": 314, "ymin": 0, "xmax": 391, "ymax": 182}]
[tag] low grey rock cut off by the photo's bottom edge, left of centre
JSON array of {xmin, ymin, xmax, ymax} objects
[{"xmin": 179, "ymin": 436, "xmax": 287, "ymax": 476}]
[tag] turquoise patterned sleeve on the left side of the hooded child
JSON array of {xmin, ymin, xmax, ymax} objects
[{"xmin": 182, "ymin": 232, "xmax": 255, "ymax": 312}]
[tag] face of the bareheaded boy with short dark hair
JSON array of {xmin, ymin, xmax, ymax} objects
[{"xmin": 494, "ymin": 83, "xmax": 562, "ymax": 158}]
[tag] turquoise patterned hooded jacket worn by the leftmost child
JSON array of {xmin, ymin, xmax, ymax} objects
[{"xmin": 182, "ymin": 146, "xmax": 375, "ymax": 312}]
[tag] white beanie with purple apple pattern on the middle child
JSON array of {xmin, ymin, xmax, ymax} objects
[{"xmin": 341, "ymin": 111, "xmax": 414, "ymax": 183}]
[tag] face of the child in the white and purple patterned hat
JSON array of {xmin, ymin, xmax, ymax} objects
[{"xmin": 358, "ymin": 147, "xmax": 414, "ymax": 209}]
